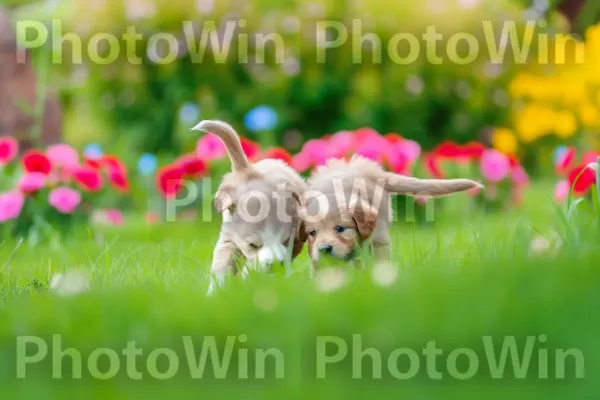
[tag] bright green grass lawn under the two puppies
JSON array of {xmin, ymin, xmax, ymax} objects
[{"xmin": 0, "ymin": 185, "xmax": 600, "ymax": 399}]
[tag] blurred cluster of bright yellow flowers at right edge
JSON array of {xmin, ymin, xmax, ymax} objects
[{"xmin": 493, "ymin": 21, "xmax": 600, "ymax": 173}]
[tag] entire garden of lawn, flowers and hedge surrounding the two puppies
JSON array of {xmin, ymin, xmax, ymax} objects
[{"xmin": 0, "ymin": 0, "xmax": 600, "ymax": 400}]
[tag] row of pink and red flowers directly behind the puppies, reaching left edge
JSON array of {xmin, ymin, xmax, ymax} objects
[{"xmin": 0, "ymin": 128, "xmax": 528, "ymax": 242}]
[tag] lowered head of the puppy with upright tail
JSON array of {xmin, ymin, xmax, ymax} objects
[{"xmin": 215, "ymin": 178, "xmax": 306, "ymax": 269}]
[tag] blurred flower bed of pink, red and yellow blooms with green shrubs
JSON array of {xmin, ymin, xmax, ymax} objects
[{"xmin": 7, "ymin": 0, "xmax": 600, "ymax": 239}]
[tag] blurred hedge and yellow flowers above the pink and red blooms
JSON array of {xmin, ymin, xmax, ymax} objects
[{"xmin": 0, "ymin": 0, "xmax": 600, "ymax": 173}]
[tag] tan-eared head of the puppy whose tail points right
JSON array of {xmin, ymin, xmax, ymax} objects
[{"xmin": 301, "ymin": 194, "xmax": 378, "ymax": 261}]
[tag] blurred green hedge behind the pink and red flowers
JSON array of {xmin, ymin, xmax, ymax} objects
[{"xmin": 10, "ymin": 0, "xmax": 567, "ymax": 162}]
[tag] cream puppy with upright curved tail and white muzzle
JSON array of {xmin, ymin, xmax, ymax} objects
[{"xmin": 193, "ymin": 120, "xmax": 307, "ymax": 293}]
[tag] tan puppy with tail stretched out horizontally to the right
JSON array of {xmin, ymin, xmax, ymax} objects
[{"xmin": 301, "ymin": 155, "xmax": 482, "ymax": 272}]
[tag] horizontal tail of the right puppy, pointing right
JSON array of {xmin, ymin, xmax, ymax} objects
[{"xmin": 385, "ymin": 173, "xmax": 483, "ymax": 197}]
